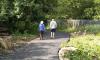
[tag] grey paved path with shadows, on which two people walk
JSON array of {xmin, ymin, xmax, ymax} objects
[{"xmin": 0, "ymin": 32, "xmax": 68, "ymax": 60}]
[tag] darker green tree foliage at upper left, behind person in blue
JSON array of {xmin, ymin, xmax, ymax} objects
[{"xmin": 0, "ymin": 0, "xmax": 57, "ymax": 33}]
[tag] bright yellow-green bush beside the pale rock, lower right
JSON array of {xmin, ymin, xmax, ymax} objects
[{"xmin": 61, "ymin": 35, "xmax": 100, "ymax": 60}]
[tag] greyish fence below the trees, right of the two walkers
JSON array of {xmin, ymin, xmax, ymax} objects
[{"xmin": 57, "ymin": 20, "xmax": 100, "ymax": 28}]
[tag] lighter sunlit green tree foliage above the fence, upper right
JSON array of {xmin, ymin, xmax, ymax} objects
[{"xmin": 57, "ymin": 0, "xmax": 100, "ymax": 19}]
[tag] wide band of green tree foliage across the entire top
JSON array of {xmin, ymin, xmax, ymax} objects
[{"xmin": 0, "ymin": 0, "xmax": 100, "ymax": 31}]
